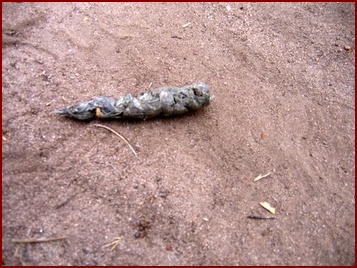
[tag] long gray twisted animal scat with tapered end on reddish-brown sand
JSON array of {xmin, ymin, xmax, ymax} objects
[{"xmin": 55, "ymin": 82, "xmax": 212, "ymax": 120}]
